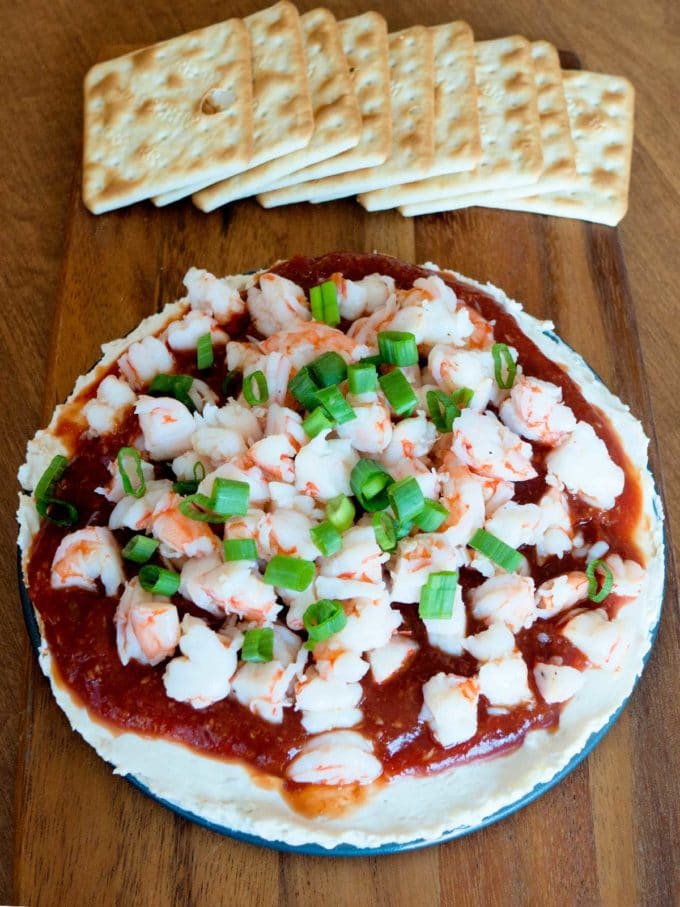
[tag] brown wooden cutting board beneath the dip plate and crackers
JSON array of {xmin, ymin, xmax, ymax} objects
[{"xmin": 15, "ymin": 103, "xmax": 674, "ymax": 907}]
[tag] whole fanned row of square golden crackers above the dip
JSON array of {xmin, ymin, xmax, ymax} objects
[{"xmin": 83, "ymin": 0, "xmax": 634, "ymax": 225}]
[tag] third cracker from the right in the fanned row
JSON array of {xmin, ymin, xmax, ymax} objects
[{"xmin": 380, "ymin": 35, "xmax": 543, "ymax": 213}]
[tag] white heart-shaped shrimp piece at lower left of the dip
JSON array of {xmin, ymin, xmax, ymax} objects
[{"xmin": 163, "ymin": 614, "xmax": 238, "ymax": 709}]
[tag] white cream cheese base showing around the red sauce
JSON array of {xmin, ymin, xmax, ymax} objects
[{"xmin": 17, "ymin": 263, "xmax": 664, "ymax": 848}]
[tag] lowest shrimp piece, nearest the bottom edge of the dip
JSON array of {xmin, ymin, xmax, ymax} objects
[{"xmin": 286, "ymin": 731, "xmax": 382, "ymax": 786}]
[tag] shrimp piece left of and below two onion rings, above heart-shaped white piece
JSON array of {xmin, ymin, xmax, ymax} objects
[{"xmin": 180, "ymin": 558, "xmax": 281, "ymax": 623}]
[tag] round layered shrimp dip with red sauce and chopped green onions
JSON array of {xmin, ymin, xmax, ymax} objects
[{"xmin": 19, "ymin": 254, "xmax": 663, "ymax": 846}]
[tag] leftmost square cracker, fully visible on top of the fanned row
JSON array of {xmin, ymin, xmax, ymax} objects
[{"xmin": 83, "ymin": 19, "xmax": 253, "ymax": 214}]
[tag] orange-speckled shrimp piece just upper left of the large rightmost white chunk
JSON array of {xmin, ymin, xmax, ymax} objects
[{"xmin": 451, "ymin": 408, "xmax": 537, "ymax": 482}]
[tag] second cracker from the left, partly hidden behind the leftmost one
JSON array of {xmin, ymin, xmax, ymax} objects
[{"xmin": 153, "ymin": 0, "xmax": 314, "ymax": 205}]
